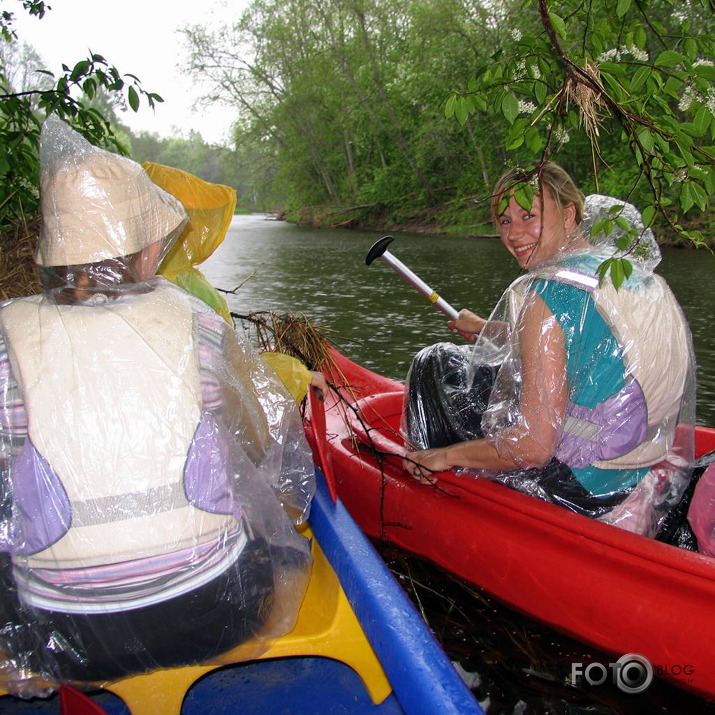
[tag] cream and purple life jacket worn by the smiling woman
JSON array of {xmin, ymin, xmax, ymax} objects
[{"xmin": 551, "ymin": 269, "xmax": 691, "ymax": 469}]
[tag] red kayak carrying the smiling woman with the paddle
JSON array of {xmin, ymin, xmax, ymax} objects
[{"xmin": 306, "ymin": 353, "xmax": 715, "ymax": 699}]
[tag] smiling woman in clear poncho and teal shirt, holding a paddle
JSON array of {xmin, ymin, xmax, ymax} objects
[{"xmin": 403, "ymin": 162, "xmax": 695, "ymax": 536}]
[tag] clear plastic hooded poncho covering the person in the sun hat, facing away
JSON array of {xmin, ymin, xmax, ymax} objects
[{"xmin": 0, "ymin": 118, "xmax": 314, "ymax": 697}]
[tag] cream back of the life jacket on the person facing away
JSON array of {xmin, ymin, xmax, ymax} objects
[{"xmin": 0, "ymin": 285, "xmax": 240, "ymax": 570}]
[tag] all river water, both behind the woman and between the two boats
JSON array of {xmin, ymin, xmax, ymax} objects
[{"xmin": 200, "ymin": 215, "xmax": 715, "ymax": 715}]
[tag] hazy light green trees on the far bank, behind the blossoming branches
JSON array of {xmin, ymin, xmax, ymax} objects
[{"xmin": 187, "ymin": 0, "xmax": 506, "ymax": 222}]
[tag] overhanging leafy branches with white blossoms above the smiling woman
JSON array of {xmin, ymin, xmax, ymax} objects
[{"xmin": 445, "ymin": 0, "xmax": 715, "ymax": 270}]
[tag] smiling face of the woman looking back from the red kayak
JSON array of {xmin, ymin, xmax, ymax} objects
[{"xmin": 497, "ymin": 188, "xmax": 576, "ymax": 269}]
